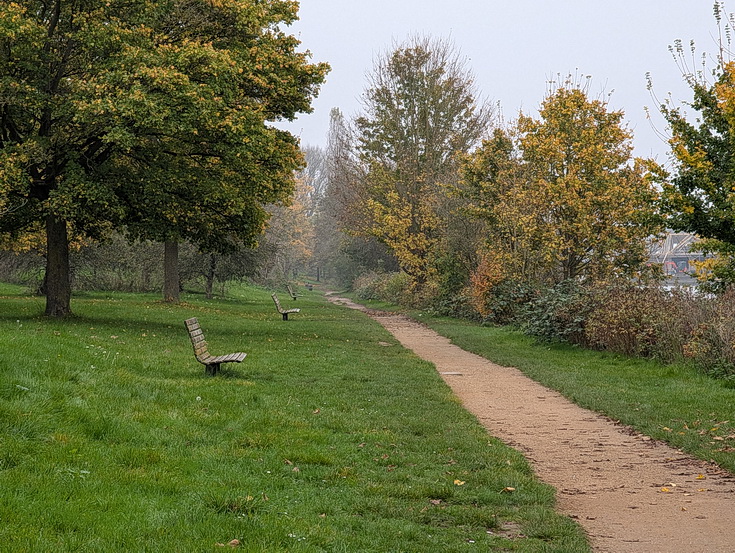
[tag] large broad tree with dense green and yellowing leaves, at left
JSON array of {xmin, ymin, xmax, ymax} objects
[{"xmin": 0, "ymin": 0, "xmax": 327, "ymax": 316}]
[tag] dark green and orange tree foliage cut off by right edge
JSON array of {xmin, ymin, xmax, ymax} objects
[{"xmin": 659, "ymin": 2, "xmax": 735, "ymax": 289}]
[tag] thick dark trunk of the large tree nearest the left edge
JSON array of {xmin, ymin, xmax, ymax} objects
[{"xmin": 44, "ymin": 215, "xmax": 71, "ymax": 318}]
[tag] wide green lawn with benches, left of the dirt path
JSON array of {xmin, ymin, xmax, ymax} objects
[{"xmin": 0, "ymin": 285, "xmax": 589, "ymax": 553}]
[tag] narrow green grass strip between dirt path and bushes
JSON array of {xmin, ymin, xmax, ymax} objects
[{"xmin": 421, "ymin": 315, "xmax": 735, "ymax": 473}]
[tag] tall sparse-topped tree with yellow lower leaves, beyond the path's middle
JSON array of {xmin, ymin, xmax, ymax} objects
[{"xmin": 355, "ymin": 37, "xmax": 492, "ymax": 290}]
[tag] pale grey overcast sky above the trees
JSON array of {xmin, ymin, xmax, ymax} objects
[{"xmin": 279, "ymin": 0, "xmax": 724, "ymax": 162}]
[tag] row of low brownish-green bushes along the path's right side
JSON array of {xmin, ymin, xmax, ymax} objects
[{"xmin": 354, "ymin": 273, "xmax": 735, "ymax": 380}]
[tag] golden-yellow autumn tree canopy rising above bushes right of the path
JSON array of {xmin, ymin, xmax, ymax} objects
[{"xmin": 463, "ymin": 83, "xmax": 657, "ymax": 292}]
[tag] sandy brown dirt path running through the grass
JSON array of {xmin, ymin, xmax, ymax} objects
[{"xmin": 330, "ymin": 297, "xmax": 735, "ymax": 553}]
